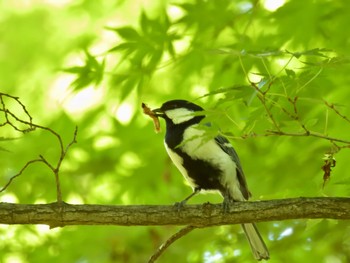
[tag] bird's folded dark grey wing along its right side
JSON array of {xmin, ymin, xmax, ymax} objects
[{"xmin": 215, "ymin": 136, "xmax": 251, "ymax": 200}]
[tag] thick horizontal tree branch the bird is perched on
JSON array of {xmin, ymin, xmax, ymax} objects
[{"xmin": 0, "ymin": 197, "xmax": 350, "ymax": 227}]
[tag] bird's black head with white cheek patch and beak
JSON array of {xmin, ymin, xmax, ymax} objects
[{"xmin": 152, "ymin": 100, "xmax": 204, "ymax": 125}]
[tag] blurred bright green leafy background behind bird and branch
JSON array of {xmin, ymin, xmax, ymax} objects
[{"xmin": 0, "ymin": 0, "xmax": 350, "ymax": 263}]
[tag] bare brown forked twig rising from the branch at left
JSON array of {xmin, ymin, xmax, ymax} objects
[{"xmin": 0, "ymin": 92, "xmax": 78, "ymax": 203}]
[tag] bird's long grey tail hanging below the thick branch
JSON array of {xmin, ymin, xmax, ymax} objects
[{"xmin": 242, "ymin": 224, "xmax": 270, "ymax": 260}]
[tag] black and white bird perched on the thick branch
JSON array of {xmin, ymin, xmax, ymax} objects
[{"xmin": 152, "ymin": 100, "xmax": 269, "ymax": 260}]
